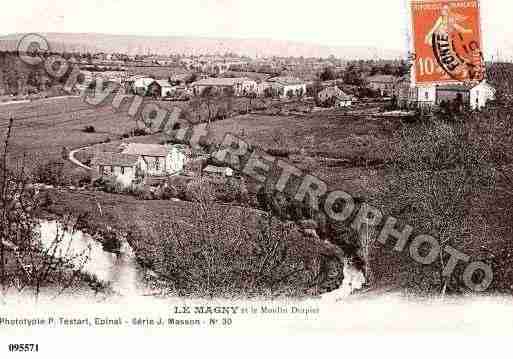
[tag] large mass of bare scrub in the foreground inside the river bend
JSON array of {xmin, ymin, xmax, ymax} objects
[{"xmin": 128, "ymin": 208, "xmax": 342, "ymax": 298}]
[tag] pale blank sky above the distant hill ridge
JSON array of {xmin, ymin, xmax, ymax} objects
[{"xmin": 0, "ymin": 0, "xmax": 513, "ymax": 57}]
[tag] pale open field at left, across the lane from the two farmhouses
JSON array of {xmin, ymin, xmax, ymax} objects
[{"xmin": 0, "ymin": 98, "xmax": 135, "ymax": 172}]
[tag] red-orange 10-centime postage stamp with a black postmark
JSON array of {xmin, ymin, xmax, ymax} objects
[{"xmin": 411, "ymin": 0, "xmax": 485, "ymax": 85}]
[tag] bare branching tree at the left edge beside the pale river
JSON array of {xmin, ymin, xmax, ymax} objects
[{"xmin": 0, "ymin": 119, "xmax": 94, "ymax": 299}]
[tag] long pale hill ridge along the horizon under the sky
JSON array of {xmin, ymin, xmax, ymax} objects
[{"xmin": 0, "ymin": 33, "xmax": 404, "ymax": 60}]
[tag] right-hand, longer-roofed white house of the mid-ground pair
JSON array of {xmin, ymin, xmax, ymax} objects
[{"xmin": 121, "ymin": 143, "xmax": 185, "ymax": 176}]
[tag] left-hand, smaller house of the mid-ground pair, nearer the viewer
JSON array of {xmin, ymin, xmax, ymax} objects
[{"xmin": 91, "ymin": 152, "xmax": 142, "ymax": 183}]
